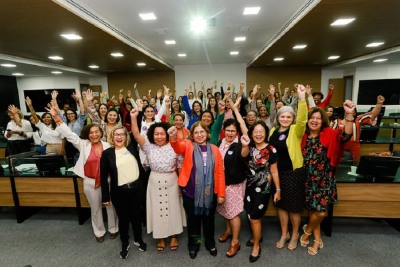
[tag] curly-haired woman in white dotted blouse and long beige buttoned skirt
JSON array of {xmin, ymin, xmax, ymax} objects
[{"xmin": 131, "ymin": 109, "xmax": 186, "ymax": 252}]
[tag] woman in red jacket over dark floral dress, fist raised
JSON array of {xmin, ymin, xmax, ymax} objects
[{"xmin": 300, "ymin": 100, "xmax": 355, "ymax": 256}]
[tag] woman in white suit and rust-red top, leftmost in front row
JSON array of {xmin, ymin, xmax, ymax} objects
[{"xmin": 48, "ymin": 101, "xmax": 118, "ymax": 247}]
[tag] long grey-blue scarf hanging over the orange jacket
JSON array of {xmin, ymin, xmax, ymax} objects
[{"xmin": 193, "ymin": 143, "xmax": 214, "ymax": 215}]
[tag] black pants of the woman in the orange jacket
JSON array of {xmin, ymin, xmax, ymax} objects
[{"xmin": 182, "ymin": 195, "xmax": 217, "ymax": 251}]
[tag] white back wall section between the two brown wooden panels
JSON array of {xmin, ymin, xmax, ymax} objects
[{"xmin": 175, "ymin": 63, "xmax": 246, "ymax": 95}]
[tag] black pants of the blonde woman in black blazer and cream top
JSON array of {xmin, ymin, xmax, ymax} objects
[{"xmin": 112, "ymin": 180, "xmax": 144, "ymax": 246}]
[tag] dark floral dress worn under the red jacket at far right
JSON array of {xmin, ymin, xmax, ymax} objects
[{"xmin": 303, "ymin": 137, "xmax": 337, "ymax": 212}]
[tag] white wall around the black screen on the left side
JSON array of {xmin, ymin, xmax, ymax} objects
[{"xmin": 17, "ymin": 76, "xmax": 108, "ymax": 114}]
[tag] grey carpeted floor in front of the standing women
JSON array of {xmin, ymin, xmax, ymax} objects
[{"xmin": 0, "ymin": 208, "xmax": 400, "ymax": 267}]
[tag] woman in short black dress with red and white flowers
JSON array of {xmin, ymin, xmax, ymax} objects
[{"xmin": 241, "ymin": 121, "xmax": 281, "ymax": 262}]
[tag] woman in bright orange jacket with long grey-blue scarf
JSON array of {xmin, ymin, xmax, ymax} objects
[{"xmin": 168, "ymin": 121, "xmax": 225, "ymax": 259}]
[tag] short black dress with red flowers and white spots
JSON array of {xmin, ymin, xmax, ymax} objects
[{"xmin": 244, "ymin": 145, "xmax": 278, "ymax": 219}]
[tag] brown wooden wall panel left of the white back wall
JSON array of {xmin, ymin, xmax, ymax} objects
[{"xmin": 107, "ymin": 71, "xmax": 175, "ymax": 100}]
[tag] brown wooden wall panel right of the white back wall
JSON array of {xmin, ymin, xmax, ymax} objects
[{"xmin": 245, "ymin": 67, "xmax": 320, "ymax": 94}]
